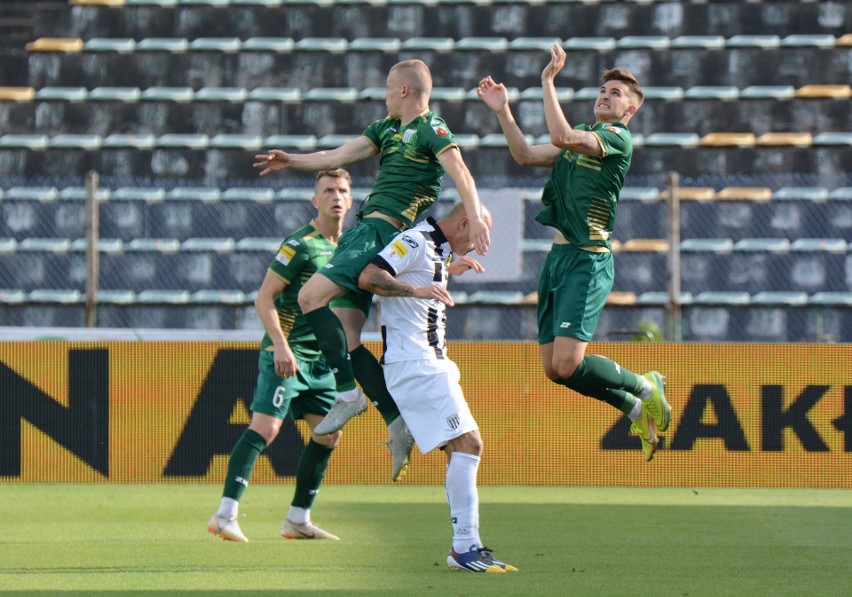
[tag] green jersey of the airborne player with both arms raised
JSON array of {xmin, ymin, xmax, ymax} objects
[{"xmin": 535, "ymin": 122, "xmax": 633, "ymax": 250}]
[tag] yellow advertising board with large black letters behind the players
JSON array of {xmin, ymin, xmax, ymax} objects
[{"xmin": 0, "ymin": 342, "xmax": 852, "ymax": 489}]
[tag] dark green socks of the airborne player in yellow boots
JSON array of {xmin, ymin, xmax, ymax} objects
[{"xmin": 556, "ymin": 355, "xmax": 643, "ymax": 414}]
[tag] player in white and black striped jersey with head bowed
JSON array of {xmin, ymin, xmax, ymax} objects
[{"xmin": 358, "ymin": 204, "xmax": 517, "ymax": 573}]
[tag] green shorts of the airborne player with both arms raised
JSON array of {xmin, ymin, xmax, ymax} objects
[{"xmin": 538, "ymin": 244, "xmax": 615, "ymax": 344}]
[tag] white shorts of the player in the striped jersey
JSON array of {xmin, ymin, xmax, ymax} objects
[{"xmin": 385, "ymin": 360, "xmax": 478, "ymax": 454}]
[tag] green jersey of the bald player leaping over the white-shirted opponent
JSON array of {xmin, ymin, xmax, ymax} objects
[{"xmin": 358, "ymin": 112, "xmax": 458, "ymax": 226}]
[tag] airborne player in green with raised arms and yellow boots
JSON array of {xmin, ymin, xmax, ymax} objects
[{"xmin": 478, "ymin": 44, "xmax": 671, "ymax": 461}]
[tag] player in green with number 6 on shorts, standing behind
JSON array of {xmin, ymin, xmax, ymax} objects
[{"xmin": 207, "ymin": 169, "xmax": 352, "ymax": 542}]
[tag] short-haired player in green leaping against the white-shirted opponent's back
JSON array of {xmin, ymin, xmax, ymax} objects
[{"xmin": 254, "ymin": 60, "xmax": 490, "ymax": 480}]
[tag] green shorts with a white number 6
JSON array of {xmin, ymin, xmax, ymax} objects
[{"xmin": 251, "ymin": 350, "xmax": 337, "ymax": 421}]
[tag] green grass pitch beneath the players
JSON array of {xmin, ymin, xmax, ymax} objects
[{"xmin": 0, "ymin": 483, "xmax": 852, "ymax": 597}]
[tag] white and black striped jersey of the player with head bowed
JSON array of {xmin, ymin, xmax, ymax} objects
[{"xmin": 373, "ymin": 217, "xmax": 452, "ymax": 363}]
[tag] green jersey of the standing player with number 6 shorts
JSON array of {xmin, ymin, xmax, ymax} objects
[{"xmin": 260, "ymin": 222, "xmax": 337, "ymax": 361}]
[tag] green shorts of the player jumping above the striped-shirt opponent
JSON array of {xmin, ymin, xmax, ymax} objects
[{"xmin": 319, "ymin": 218, "xmax": 399, "ymax": 314}]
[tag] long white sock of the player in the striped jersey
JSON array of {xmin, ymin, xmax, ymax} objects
[{"xmin": 445, "ymin": 452, "xmax": 482, "ymax": 553}]
